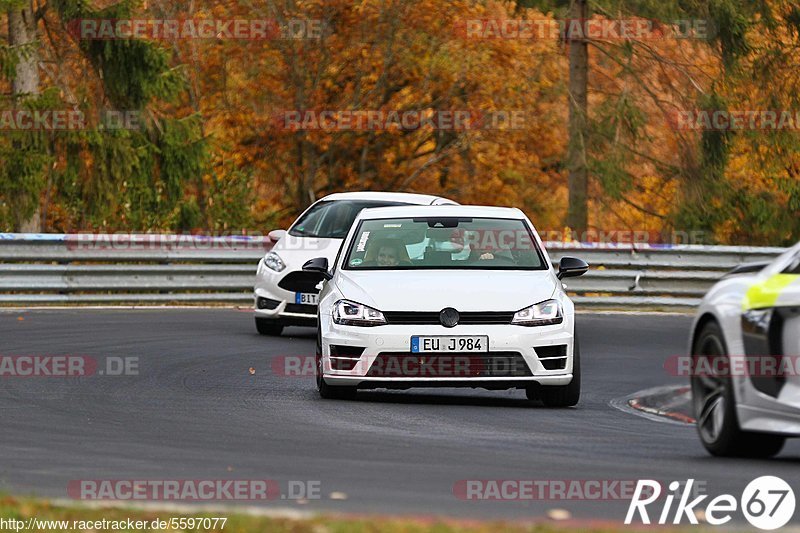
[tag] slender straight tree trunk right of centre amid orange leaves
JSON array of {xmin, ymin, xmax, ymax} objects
[{"xmin": 567, "ymin": 0, "xmax": 589, "ymax": 234}]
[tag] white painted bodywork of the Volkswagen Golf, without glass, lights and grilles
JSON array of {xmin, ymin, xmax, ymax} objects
[{"xmin": 319, "ymin": 206, "xmax": 575, "ymax": 386}]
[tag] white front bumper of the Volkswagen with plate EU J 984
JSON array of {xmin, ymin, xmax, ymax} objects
[{"xmin": 320, "ymin": 315, "xmax": 574, "ymax": 389}]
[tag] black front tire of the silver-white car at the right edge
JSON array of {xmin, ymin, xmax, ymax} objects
[{"xmin": 691, "ymin": 321, "xmax": 786, "ymax": 458}]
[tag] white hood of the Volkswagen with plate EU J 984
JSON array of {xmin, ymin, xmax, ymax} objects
[{"xmin": 336, "ymin": 270, "xmax": 559, "ymax": 311}]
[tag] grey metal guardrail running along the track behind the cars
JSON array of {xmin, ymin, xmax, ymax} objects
[{"xmin": 0, "ymin": 233, "xmax": 784, "ymax": 309}]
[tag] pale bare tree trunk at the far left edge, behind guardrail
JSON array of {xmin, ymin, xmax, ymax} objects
[{"xmin": 8, "ymin": 0, "xmax": 41, "ymax": 233}]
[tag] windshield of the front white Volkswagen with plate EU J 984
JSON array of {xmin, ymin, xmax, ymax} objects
[{"xmin": 344, "ymin": 217, "xmax": 547, "ymax": 270}]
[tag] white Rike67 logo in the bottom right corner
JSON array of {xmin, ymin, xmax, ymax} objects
[{"xmin": 625, "ymin": 476, "xmax": 795, "ymax": 530}]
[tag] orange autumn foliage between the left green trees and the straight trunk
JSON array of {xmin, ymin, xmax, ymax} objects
[{"xmin": 184, "ymin": 0, "xmax": 566, "ymax": 229}]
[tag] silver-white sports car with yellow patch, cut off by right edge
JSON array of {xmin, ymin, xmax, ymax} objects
[{"xmin": 690, "ymin": 239, "xmax": 800, "ymax": 457}]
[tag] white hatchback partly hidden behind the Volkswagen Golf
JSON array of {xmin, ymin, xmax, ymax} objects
[{"xmin": 254, "ymin": 192, "xmax": 456, "ymax": 335}]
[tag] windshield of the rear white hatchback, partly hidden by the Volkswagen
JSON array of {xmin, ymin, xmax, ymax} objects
[{"xmin": 289, "ymin": 200, "xmax": 408, "ymax": 239}]
